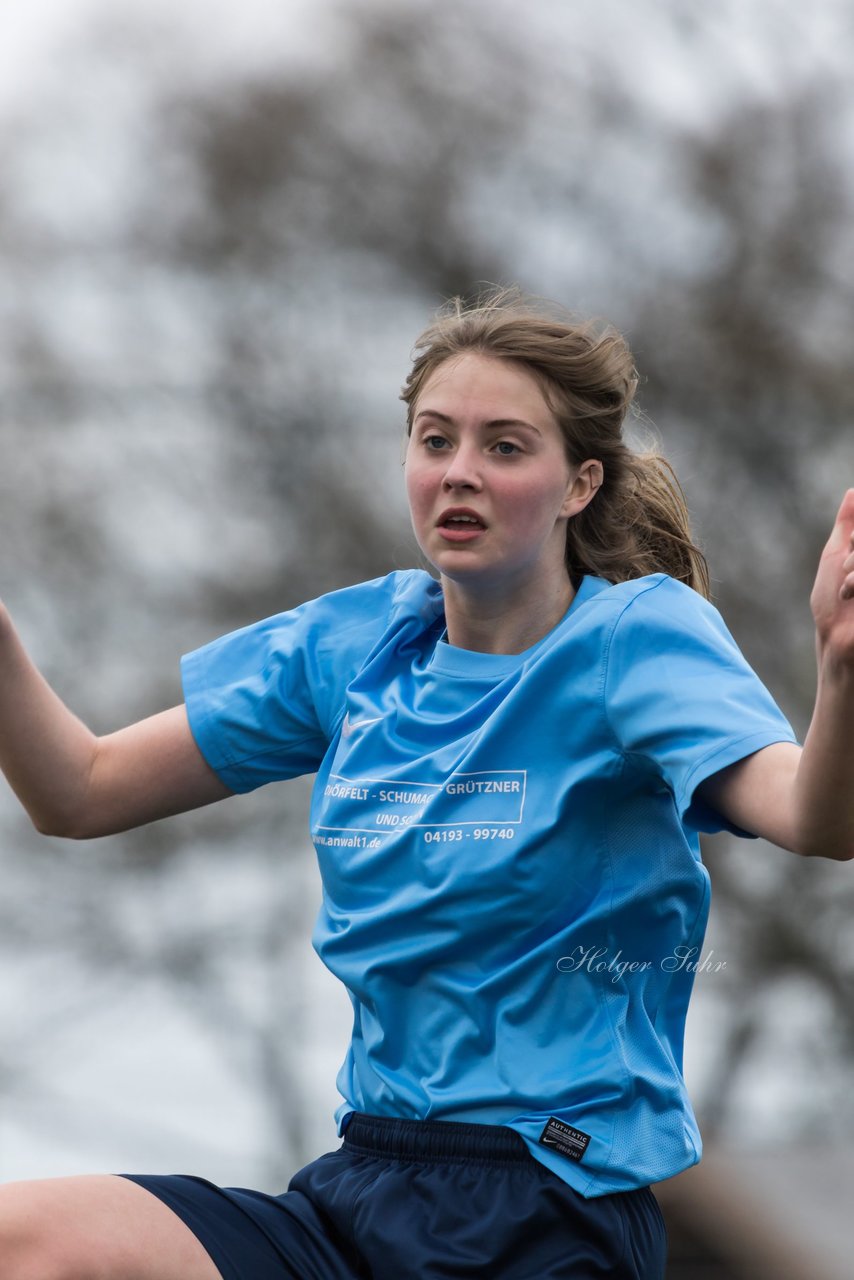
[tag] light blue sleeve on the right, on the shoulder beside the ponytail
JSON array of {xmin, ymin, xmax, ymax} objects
[{"xmin": 604, "ymin": 575, "xmax": 796, "ymax": 836}]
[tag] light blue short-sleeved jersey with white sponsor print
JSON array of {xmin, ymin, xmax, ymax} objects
[{"xmin": 183, "ymin": 571, "xmax": 795, "ymax": 1196}]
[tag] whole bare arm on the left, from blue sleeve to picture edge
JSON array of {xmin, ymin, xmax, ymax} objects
[{"xmin": 0, "ymin": 604, "xmax": 232, "ymax": 840}]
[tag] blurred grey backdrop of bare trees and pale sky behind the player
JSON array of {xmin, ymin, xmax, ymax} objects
[{"xmin": 0, "ymin": 0, "xmax": 854, "ymax": 1280}]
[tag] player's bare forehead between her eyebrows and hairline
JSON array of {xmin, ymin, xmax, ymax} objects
[{"xmin": 415, "ymin": 352, "xmax": 557, "ymax": 426}]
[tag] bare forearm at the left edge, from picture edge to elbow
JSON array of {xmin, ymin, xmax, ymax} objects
[{"xmin": 0, "ymin": 605, "xmax": 97, "ymax": 835}]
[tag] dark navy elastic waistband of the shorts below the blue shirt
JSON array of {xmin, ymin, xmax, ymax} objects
[{"xmin": 344, "ymin": 1111, "xmax": 536, "ymax": 1164}]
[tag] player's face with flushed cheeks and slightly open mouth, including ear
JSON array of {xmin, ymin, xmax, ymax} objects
[{"xmin": 406, "ymin": 352, "xmax": 600, "ymax": 593}]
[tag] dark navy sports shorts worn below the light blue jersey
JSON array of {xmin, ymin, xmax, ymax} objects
[{"xmin": 125, "ymin": 1114, "xmax": 666, "ymax": 1280}]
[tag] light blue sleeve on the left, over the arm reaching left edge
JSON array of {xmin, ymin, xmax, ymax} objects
[{"xmin": 181, "ymin": 575, "xmax": 422, "ymax": 792}]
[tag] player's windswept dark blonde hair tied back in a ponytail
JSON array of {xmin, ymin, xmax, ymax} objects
[{"xmin": 401, "ymin": 289, "xmax": 711, "ymax": 599}]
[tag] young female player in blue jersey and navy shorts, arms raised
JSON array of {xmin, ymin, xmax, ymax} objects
[{"xmin": 0, "ymin": 297, "xmax": 854, "ymax": 1280}]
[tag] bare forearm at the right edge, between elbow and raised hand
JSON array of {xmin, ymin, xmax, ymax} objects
[{"xmin": 793, "ymin": 646, "xmax": 854, "ymax": 859}]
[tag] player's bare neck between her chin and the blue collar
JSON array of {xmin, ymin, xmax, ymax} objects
[{"xmin": 442, "ymin": 576, "xmax": 575, "ymax": 654}]
